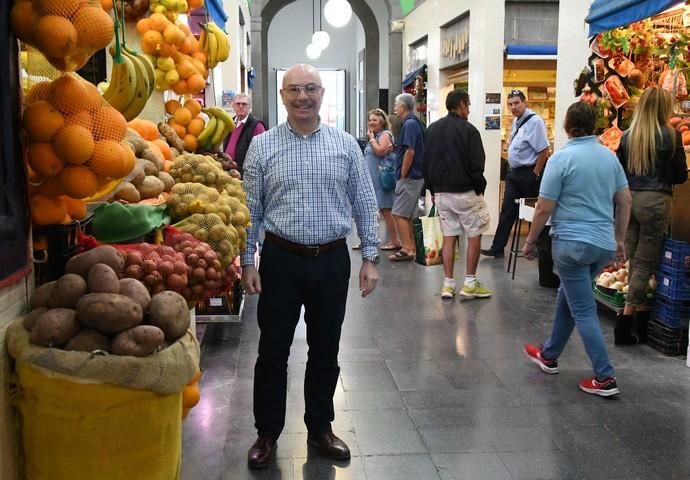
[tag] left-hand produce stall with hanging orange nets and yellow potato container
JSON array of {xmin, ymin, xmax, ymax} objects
[{"xmin": 3, "ymin": 0, "xmax": 243, "ymax": 474}]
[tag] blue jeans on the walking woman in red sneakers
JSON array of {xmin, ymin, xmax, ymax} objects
[{"xmin": 542, "ymin": 238, "xmax": 615, "ymax": 380}]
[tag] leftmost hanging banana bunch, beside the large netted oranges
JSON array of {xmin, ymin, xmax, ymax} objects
[{"xmin": 101, "ymin": 45, "xmax": 156, "ymax": 121}]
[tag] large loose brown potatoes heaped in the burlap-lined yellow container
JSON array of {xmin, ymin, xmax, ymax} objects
[{"xmin": 24, "ymin": 246, "xmax": 190, "ymax": 357}]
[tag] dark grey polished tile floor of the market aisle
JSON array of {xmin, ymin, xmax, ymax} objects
[{"xmin": 182, "ymin": 234, "xmax": 690, "ymax": 480}]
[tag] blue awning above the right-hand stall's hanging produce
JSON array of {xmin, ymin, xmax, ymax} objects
[{"xmin": 585, "ymin": 0, "xmax": 681, "ymax": 37}]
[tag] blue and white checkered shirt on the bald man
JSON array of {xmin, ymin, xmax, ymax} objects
[{"xmin": 241, "ymin": 122, "xmax": 379, "ymax": 265}]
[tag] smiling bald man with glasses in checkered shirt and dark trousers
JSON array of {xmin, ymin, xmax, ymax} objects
[{"xmin": 241, "ymin": 64, "xmax": 379, "ymax": 469}]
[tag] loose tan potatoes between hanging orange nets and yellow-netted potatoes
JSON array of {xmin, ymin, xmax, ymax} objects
[{"xmin": 115, "ymin": 130, "xmax": 175, "ymax": 203}]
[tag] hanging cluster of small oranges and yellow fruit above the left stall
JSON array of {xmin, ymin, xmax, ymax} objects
[{"xmin": 137, "ymin": 13, "xmax": 208, "ymax": 95}]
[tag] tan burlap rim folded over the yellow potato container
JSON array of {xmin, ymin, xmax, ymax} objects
[{"xmin": 7, "ymin": 318, "xmax": 200, "ymax": 395}]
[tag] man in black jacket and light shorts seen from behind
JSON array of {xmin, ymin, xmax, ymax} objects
[{"xmin": 424, "ymin": 89, "xmax": 492, "ymax": 298}]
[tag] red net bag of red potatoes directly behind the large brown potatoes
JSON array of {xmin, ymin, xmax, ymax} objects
[{"xmin": 123, "ymin": 243, "xmax": 191, "ymax": 294}]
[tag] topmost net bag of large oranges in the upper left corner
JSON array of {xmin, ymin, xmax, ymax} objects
[{"xmin": 10, "ymin": 0, "xmax": 114, "ymax": 72}]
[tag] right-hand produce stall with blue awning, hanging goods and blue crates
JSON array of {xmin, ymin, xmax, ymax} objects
[{"xmin": 574, "ymin": 0, "xmax": 690, "ymax": 355}]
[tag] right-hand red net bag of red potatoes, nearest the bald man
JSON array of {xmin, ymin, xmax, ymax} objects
[{"xmin": 166, "ymin": 233, "xmax": 224, "ymax": 302}]
